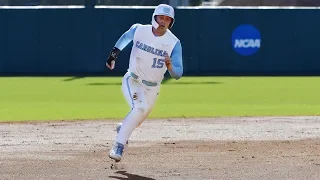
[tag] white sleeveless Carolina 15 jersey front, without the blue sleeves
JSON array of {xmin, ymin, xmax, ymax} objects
[{"xmin": 129, "ymin": 25, "xmax": 178, "ymax": 83}]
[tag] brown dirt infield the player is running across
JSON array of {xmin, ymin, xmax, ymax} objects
[{"xmin": 0, "ymin": 117, "xmax": 320, "ymax": 180}]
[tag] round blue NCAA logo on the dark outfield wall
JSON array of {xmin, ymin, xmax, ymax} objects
[{"xmin": 232, "ymin": 24, "xmax": 261, "ymax": 56}]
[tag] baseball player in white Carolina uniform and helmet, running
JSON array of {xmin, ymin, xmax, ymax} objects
[{"xmin": 106, "ymin": 4, "xmax": 183, "ymax": 162}]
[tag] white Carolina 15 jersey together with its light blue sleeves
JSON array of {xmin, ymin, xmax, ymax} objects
[{"xmin": 115, "ymin": 24, "xmax": 182, "ymax": 83}]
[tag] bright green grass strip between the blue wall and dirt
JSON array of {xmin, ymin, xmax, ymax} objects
[{"xmin": 0, "ymin": 77, "xmax": 320, "ymax": 121}]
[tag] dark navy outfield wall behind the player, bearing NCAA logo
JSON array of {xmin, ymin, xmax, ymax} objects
[{"xmin": 0, "ymin": 6, "xmax": 320, "ymax": 76}]
